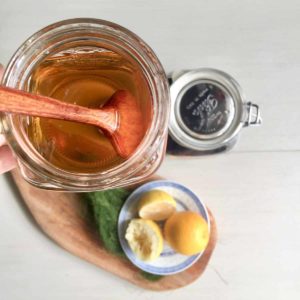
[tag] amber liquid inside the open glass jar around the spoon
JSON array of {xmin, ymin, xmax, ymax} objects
[{"xmin": 25, "ymin": 49, "xmax": 152, "ymax": 173}]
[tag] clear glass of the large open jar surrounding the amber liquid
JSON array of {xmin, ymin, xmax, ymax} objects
[{"xmin": 1, "ymin": 19, "xmax": 170, "ymax": 191}]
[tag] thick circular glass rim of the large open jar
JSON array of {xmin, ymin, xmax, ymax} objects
[{"xmin": 2, "ymin": 18, "xmax": 170, "ymax": 186}]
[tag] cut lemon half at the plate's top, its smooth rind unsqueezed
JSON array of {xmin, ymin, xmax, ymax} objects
[{"xmin": 138, "ymin": 190, "xmax": 176, "ymax": 221}]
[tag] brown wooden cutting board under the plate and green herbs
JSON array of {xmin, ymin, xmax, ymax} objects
[{"xmin": 13, "ymin": 171, "xmax": 217, "ymax": 291}]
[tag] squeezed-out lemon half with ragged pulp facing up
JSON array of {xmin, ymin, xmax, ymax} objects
[{"xmin": 125, "ymin": 219, "xmax": 163, "ymax": 261}]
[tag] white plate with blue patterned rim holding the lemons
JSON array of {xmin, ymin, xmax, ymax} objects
[{"xmin": 118, "ymin": 180, "xmax": 210, "ymax": 275}]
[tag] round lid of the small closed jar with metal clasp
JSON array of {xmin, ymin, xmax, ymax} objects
[{"xmin": 169, "ymin": 68, "xmax": 246, "ymax": 151}]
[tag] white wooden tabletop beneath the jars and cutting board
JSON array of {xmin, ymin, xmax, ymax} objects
[{"xmin": 0, "ymin": 0, "xmax": 300, "ymax": 300}]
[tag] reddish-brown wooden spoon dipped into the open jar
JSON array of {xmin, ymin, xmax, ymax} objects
[{"xmin": 0, "ymin": 86, "xmax": 143, "ymax": 158}]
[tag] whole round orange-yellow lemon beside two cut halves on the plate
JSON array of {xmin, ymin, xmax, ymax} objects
[{"xmin": 164, "ymin": 211, "xmax": 209, "ymax": 255}]
